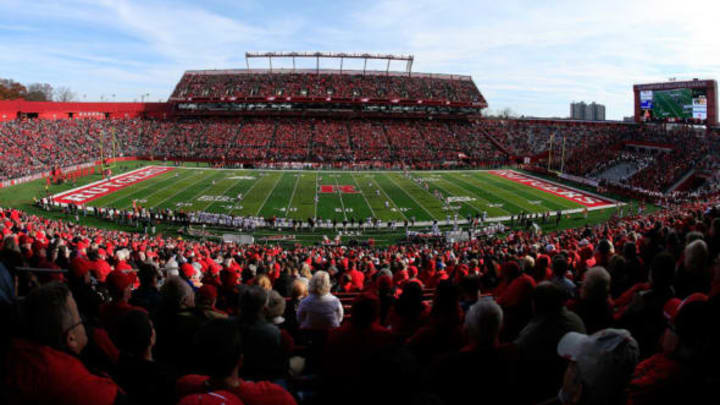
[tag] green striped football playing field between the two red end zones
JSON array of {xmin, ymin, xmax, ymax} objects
[{"xmin": 60, "ymin": 167, "xmax": 612, "ymax": 222}]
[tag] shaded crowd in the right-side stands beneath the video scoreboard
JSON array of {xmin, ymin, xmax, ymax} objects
[{"xmin": 483, "ymin": 120, "xmax": 720, "ymax": 193}]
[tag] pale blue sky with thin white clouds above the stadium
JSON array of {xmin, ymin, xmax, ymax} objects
[{"xmin": 0, "ymin": 0, "xmax": 720, "ymax": 119}]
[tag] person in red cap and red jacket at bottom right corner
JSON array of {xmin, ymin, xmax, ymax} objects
[{"xmin": 628, "ymin": 293, "xmax": 715, "ymax": 405}]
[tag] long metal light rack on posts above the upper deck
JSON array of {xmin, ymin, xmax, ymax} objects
[{"xmin": 245, "ymin": 52, "xmax": 415, "ymax": 75}]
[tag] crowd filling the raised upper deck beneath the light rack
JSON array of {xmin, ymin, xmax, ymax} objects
[{"xmin": 171, "ymin": 72, "xmax": 485, "ymax": 103}]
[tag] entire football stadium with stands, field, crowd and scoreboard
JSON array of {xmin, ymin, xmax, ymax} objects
[{"xmin": 0, "ymin": 5, "xmax": 720, "ymax": 405}]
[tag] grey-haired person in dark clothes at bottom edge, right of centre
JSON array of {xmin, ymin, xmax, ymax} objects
[{"xmin": 426, "ymin": 296, "xmax": 518, "ymax": 404}]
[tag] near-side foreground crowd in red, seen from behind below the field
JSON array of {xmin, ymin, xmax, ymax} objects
[{"xmin": 0, "ymin": 192, "xmax": 720, "ymax": 405}]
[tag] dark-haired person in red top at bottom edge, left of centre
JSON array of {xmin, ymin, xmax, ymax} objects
[{"xmin": 176, "ymin": 319, "xmax": 296, "ymax": 405}]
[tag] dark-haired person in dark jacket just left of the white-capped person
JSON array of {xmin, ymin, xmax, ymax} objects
[{"xmin": 515, "ymin": 281, "xmax": 585, "ymax": 403}]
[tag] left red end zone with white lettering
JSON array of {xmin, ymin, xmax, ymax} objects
[{"xmin": 53, "ymin": 166, "xmax": 174, "ymax": 205}]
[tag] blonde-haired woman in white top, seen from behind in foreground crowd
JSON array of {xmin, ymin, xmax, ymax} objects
[{"xmin": 297, "ymin": 271, "xmax": 344, "ymax": 330}]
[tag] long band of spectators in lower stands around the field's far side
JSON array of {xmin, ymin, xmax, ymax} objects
[{"xmin": 0, "ymin": 115, "xmax": 720, "ymax": 193}]
